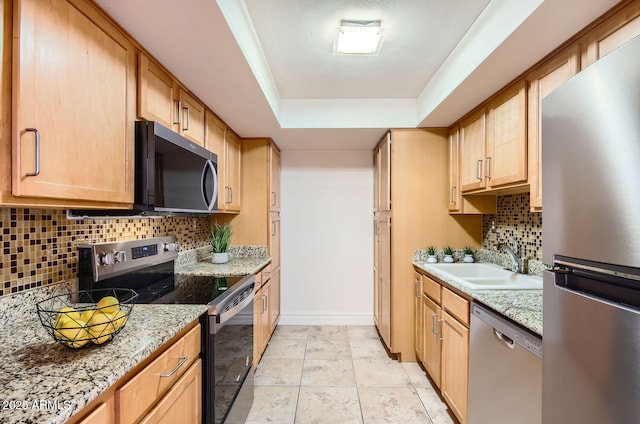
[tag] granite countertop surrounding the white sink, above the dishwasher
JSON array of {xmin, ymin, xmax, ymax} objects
[{"xmin": 413, "ymin": 260, "xmax": 542, "ymax": 336}]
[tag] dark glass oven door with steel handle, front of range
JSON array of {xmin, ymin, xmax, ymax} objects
[{"xmin": 204, "ymin": 283, "xmax": 255, "ymax": 424}]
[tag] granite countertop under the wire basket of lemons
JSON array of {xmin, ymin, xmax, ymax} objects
[{"xmin": 0, "ymin": 289, "xmax": 207, "ymax": 424}]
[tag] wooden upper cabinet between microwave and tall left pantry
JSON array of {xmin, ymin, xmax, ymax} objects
[{"xmin": 205, "ymin": 111, "xmax": 242, "ymax": 213}]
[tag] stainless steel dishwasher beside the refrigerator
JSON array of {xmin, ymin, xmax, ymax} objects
[{"xmin": 467, "ymin": 303, "xmax": 542, "ymax": 424}]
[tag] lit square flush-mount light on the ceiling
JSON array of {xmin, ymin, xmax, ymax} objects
[{"xmin": 333, "ymin": 21, "xmax": 384, "ymax": 56}]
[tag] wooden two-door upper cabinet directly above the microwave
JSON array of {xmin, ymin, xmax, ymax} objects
[{"xmin": 138, "ymin": 52, "xmax": 206, "ymax": 147}]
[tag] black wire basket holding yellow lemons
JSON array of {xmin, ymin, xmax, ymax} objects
[{"xmin": 36, "ymin": 289, "xmax": 138, "ymax": 349}]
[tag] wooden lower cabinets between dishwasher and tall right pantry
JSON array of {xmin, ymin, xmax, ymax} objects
[{"xmin": 416, "ymin": 272, "xmax": 469, "ymax": 424}]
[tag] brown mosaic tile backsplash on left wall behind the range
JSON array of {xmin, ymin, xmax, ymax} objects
[{"xmin": 0, "ymin": 208, "xmax": 209, "ymax": 296}]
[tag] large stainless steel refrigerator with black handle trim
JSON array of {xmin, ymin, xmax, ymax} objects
[{"xmin": 542, "ymin": 37, "xmax": 640, "ymax": 424}]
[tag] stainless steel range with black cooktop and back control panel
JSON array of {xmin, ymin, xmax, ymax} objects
[{"xmin": 78, "ymin": 236, "xmax": 257, "ymax": 424}]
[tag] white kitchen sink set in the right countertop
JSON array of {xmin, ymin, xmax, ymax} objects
[{"xmin": 429, "ymin": 263, "xmax": 542, "ymax": 290}]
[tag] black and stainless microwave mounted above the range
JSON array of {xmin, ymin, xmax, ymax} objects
[{"xmin": 67, "ymin": 121, "xmax": 218, "ymax": 218}]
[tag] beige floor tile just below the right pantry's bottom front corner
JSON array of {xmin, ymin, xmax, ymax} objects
[{"xmin": 353, "ymin": 359, "xmax": 411, "ymax": 387}]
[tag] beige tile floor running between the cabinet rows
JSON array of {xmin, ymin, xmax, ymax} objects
[{"xmin": 246, "ymin": 326, "xmax": 455, "ymax": 424}]
